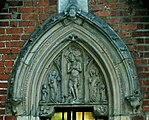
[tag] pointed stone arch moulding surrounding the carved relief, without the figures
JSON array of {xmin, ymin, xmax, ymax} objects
[{"xmin": 7, "ymin": 7, "xmax": 141, "ymax": 120}]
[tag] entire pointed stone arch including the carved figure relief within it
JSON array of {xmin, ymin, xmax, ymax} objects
[{"xmin": 7, "ymin": 6, "xmax": 141, "ymax": 120}]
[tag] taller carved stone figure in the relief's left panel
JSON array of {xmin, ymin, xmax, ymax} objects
[{"xmin": 49, "ymin": 70, "xmax": 60, "ymax": 102}]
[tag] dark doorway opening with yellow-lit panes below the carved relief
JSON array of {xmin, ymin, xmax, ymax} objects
[{"xmin": 41, "ymin": 107, "xmax": 108, "ymax": 120}]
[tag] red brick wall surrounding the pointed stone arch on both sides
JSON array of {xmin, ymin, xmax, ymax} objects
[{"xmin": 0, "ymin": 0, "xmax": 149, "ymax": 120}]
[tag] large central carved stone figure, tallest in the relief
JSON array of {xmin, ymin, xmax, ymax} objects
[{"xmin": 66, "ymin": 48, "xmax": 82, "ymax": 101}]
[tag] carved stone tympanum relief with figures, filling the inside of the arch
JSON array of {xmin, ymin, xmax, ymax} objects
[{"xmin": 40, "ymin": 37, "xmax": 107, "ymax": 116}]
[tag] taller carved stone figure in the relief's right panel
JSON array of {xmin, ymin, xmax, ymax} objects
[{"xmin": 89, "ymin": 67, "xmax": 100, "ymax": 102}]
